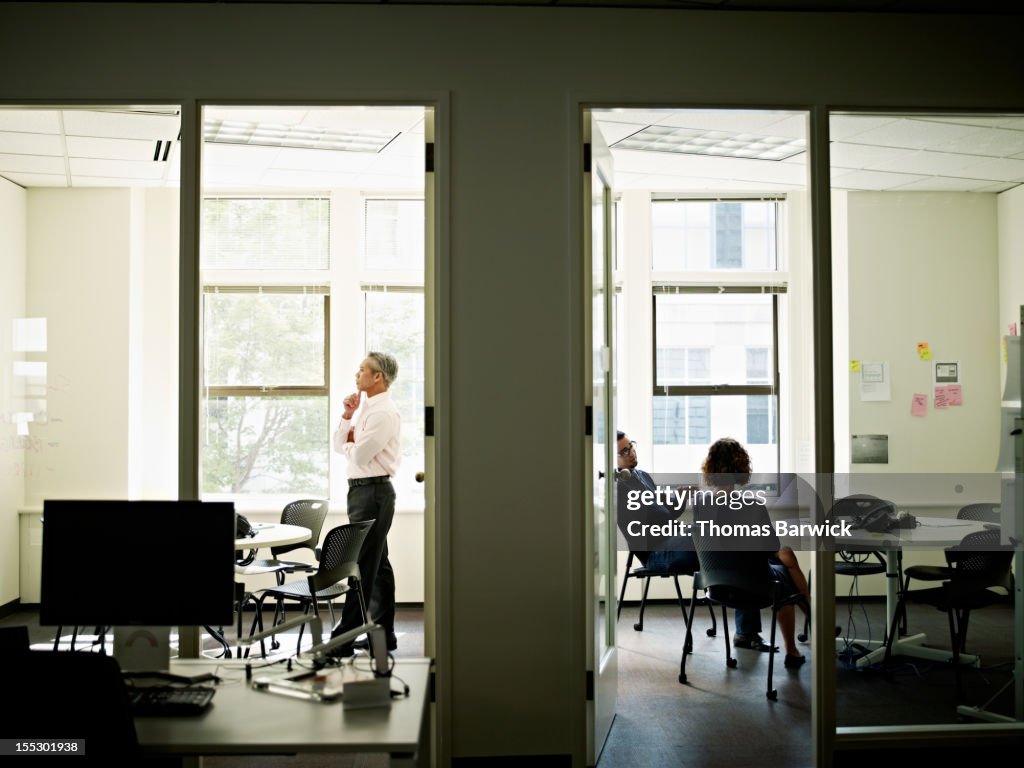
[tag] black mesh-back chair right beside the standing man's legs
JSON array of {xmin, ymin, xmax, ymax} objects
[{"xmin": 249, "ymin": 520, "xmax": 375, "ymax": 655}]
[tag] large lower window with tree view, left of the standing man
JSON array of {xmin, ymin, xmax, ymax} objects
[{"xmin": 202, "ymin": 286, "xmax": 330, "ymax": 498}]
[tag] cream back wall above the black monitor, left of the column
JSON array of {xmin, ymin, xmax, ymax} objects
[{"xmin": 25, "ymin": 188, "xmax": 132, "ymax": 508}]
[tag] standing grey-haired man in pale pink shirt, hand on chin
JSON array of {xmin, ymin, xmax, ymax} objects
[{"xmin": 331, "ymin": 352, "xmax": 401, "ymax": 656}]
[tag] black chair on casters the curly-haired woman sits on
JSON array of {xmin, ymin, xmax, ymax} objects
[{"xmin": 679, "ymin": 536, "xmax": 803, "ymax": 701}]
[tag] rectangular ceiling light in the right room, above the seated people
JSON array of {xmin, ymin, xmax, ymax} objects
[{"xmin": 611, "ymin": 125, "xmax": 807, "ymax": 160}]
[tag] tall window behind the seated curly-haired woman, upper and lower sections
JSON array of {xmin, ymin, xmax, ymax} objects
[{"xmin": 651, "ymin": 200, "xmax": 785, "ymax": 472}]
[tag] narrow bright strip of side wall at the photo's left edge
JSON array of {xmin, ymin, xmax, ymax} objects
[{"xmin": 0, "ymin": 178, "xmax": 26, "ymax": 606}]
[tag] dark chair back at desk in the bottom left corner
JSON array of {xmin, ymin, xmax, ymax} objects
[{"xmin": 12, "ymin": 650, "xmax": 139, "ymax": 765}]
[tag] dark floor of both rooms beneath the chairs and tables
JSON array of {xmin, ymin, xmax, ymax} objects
[{"xmin": 0, "ymin": 600, "xmax": 1013, "ymax": 768}]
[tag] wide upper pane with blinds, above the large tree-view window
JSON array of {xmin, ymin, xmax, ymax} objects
[{"xmin": 200, "ymin": 198, "xmax": 331, "ymax": 269}]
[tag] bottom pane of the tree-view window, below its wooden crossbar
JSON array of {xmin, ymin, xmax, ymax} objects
[{"xmin": 202, "ymin": 396, "xmax": 329, "ymax": 499}]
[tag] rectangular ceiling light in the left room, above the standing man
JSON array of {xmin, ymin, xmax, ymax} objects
[{"xmin": 203, "ymin": 120, "xmax": 398, "ymax": 153}]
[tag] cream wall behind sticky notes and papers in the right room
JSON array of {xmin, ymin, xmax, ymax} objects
[{"xmin": 847, "ymin": 193, "xmax": 999, "ymax": 481}]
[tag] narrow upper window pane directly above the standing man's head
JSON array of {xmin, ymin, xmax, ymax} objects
[{"xmin": 364, "ymin": 200, "xmax": 425, "ymax": 272}]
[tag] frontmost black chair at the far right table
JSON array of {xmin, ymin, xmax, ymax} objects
[{"xmin": 884, "ymin": 530, "xmax": 1014, "ymax": 701}]
